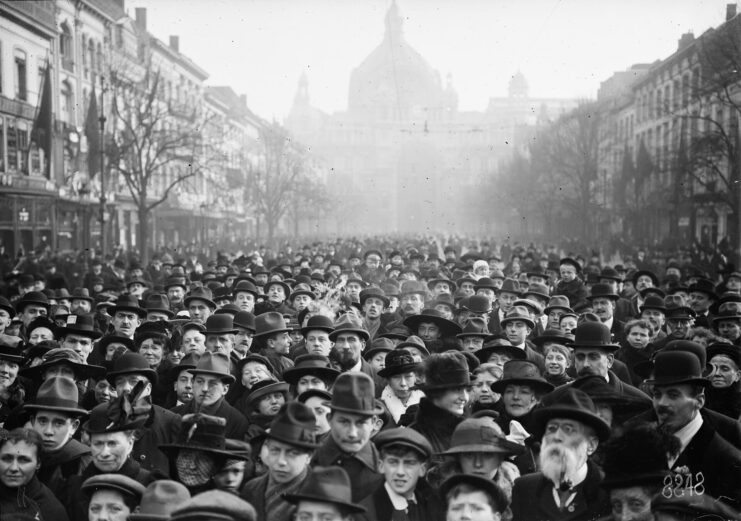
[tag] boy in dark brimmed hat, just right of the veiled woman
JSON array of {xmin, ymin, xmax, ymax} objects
[{"xmin": 241, "ymin": 401, "xmax": 317, "ymax": 521}]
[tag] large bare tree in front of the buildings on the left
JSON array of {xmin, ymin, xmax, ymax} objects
[{"xmin": 109, "ymin": 65, "xmax": 215, "ymax": 261}]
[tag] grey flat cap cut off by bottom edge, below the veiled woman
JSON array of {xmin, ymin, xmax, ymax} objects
[{"xmin": 169, "ymin": 489, "xmax": 257, "ymax": 521}]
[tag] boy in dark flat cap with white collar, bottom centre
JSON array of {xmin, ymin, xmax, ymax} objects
[{"xmin": 359, "ymin": 427, "xmax": 444, "ymax": 521}]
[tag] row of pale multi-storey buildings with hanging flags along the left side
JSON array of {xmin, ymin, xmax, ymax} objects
[{"xmin": 0, "ymin": 0, "xmax": 267, "ymax": 256}]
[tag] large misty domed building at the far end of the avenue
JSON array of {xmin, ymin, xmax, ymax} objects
[{"xmin": 285, "ymin": 0, "xmax": 576, "ymax": 234}]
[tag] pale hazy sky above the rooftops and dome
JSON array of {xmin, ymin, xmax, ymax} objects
[{"xmin": 126, "ymin": 0, "xmax": 729, "ymax": 120}]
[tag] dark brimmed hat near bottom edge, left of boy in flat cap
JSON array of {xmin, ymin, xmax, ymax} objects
[{"xmin": 283, "ymin": 467, "xmax": 365, "ymax": 513}]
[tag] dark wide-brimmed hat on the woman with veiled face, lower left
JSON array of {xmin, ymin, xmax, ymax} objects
[{"xmin": 159, "ymin": 413, "xmax": 247, "ymax": 459}]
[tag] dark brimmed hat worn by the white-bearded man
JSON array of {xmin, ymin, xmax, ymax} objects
[{"xmin": 533, "ymin": 386, "xmax": 611, "ymax": 441}]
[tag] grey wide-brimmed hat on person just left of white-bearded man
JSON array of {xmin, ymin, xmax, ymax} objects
[{"xmin": 442, "ymin": 416, "xmax": 525, "ymax": 454}]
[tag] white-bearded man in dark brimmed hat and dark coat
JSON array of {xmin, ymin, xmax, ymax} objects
[{"xmin": 511, "ymin": 386, "xmax": 610, "ymax": 521}]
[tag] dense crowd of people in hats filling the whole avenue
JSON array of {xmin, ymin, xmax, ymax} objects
[{"xmin": 0, "ymin": 237, "xmax": 741, "ymax": 521}]
